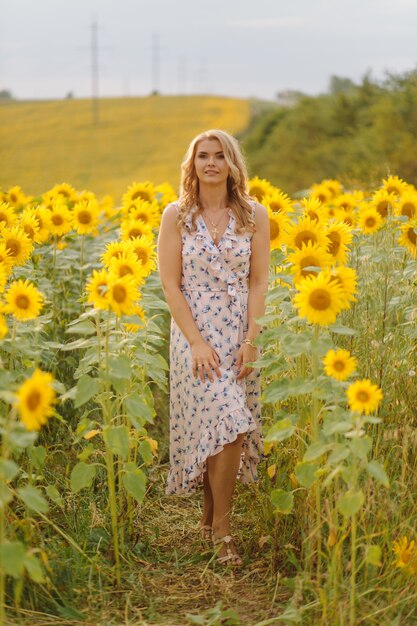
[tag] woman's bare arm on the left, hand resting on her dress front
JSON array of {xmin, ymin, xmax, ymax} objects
[{"xmin": 158, "ymin": 205, "xmax": 221, "ymax": 380}]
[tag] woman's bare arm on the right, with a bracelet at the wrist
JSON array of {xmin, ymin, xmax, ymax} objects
[{"xmin": 237, "ymin": 204, "xmax": 270, "ymax": 380}]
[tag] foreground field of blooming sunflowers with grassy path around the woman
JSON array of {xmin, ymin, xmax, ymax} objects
[{"xmin": 0, "ymin": 176, "xmax": 417, "ymax": 626}]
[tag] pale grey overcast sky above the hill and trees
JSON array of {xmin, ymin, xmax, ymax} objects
[{"xmin": 0, "ymin": 0, "xmax": 417, "ymax": 99}]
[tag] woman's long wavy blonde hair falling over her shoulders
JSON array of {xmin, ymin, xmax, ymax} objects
[{"xmin": 177, "ymin": 129, "xmax": 255, "ymax": 233}]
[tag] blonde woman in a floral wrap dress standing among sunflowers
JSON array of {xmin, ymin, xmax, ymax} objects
[{"xmin": 158, "ymin": 130, "xmax": 270, "ymax": 565}]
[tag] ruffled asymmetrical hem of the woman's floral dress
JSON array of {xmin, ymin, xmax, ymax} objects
[{"xmin": 166, "ymin": 408, "xmax": 262, "ymax": 495}]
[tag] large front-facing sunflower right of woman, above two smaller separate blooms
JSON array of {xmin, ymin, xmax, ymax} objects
[{"xmin": 294, "ymin": 270, "xmax": 344, "ymax": 326}]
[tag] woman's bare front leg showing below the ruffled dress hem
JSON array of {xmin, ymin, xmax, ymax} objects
[{"xmin": 207, "ymin": 433, "xmax": 245, "ymax": 554}]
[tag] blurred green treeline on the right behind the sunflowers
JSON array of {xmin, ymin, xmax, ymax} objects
[{"xmin": 242, "ymin": 69, "xmax": 417, "ymax": 193}]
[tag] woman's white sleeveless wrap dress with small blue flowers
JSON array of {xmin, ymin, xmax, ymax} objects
[{"xmin": 166, "ymin": 202, "xmax": 263, "ymax": 494}]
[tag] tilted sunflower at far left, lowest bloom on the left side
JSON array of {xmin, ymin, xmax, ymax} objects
[{"xmin": 16, "ymin": 368, "xmax": 56, "ymax": 430}]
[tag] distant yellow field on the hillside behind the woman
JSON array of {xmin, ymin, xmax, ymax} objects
[{"xmin": 0, "ymin": 96, "xmax": 250, "ymax": 199}]
